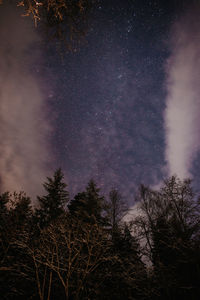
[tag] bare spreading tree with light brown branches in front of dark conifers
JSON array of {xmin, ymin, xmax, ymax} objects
[{"xmin": 20, "ymin": 215, "xmax": 109, "ymax": 300}]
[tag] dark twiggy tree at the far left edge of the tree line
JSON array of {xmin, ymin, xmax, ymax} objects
[{"xmin": 0, "ymin": 192, "xmax": 32, "ymax": 299}]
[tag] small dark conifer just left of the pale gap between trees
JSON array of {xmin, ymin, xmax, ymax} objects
[{"xmin": 99, "ymin": 224, "xmax": 147, "ymax": 300}]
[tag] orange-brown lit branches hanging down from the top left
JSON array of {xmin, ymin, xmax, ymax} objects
[{"xmin": 0, "ymin": 0, "xmax": 95, "ymax": 50}]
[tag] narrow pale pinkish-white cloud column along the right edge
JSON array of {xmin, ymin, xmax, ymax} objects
[{"xmin": 165, "ymin": 6, "xmax": 200, "ymax": 178}]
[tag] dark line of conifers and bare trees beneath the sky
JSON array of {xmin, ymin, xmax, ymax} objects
[{"xmin": 0, "ymin": 169, "xmax": 200, "ymax": 300}]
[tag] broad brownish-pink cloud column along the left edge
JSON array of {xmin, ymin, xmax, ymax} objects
[{"xmin": 0, "ymin": 5, "xmax": 50, "ymax": 196}]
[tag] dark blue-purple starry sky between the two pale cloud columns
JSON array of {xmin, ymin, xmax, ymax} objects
[{"xmin": 0, "ymin": 0, "xmax": 200, "ymax": 204}]
